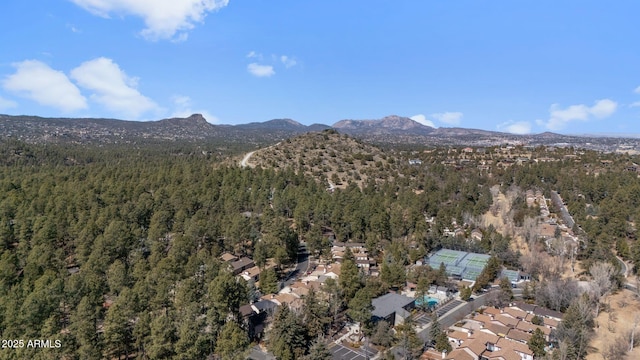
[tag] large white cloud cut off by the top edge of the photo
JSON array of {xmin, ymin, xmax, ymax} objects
[{"xmin": 71, "ymin": 0, "xmax": 229, "ymax": 40}]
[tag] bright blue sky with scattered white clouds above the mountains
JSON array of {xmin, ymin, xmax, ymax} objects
[{"xmin": 0, "ymin": 0, "xmax": 640, "ymax": 134}]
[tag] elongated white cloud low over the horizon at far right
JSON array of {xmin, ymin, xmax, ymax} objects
[{"xmin": 537, "ymin": 99, "xmax": 618, "ymax": 131}]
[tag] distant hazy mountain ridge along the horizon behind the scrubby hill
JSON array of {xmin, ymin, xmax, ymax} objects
[{"xmin": 0, "ymin": 114, "xmax": 640, "ymax": 148}]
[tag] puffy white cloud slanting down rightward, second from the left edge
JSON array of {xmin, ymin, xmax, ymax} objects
[{"xmin": 71, "ymin": 57, "xmax": 158, "ymax": 118}]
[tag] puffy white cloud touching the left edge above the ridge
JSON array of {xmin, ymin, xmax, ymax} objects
[{"xmin": 2, "ymin": 60, "xmax": 87, "ymax": 112}]
